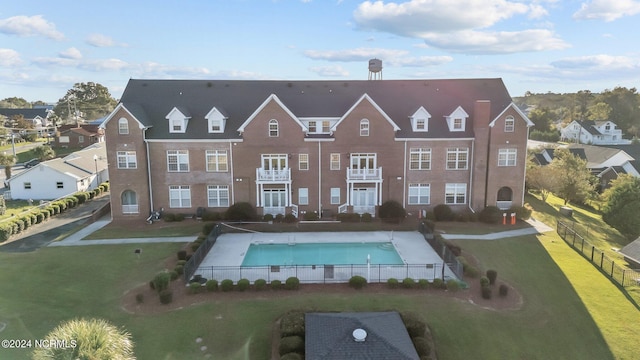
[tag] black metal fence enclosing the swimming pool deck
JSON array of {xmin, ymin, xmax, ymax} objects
[{"xmin": 184, "ymin": 224, "xmax": 463, "ymax": 283}]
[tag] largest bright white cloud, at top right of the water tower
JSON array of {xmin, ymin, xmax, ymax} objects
[{"xmin": 354, "ymin": 0, "xmax": 568, "ymax": 54}]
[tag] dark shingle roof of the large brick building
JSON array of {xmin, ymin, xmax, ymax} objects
[{"xmin": 121, "ymin": 79, "xmax": 512, "ymax": 139}]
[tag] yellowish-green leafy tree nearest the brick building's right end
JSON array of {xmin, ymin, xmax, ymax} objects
[{"xmin": 548, "ymin": 148, "xmax": 595, "ymax": 205}]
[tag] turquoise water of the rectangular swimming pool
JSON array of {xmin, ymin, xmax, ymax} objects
[{"xmin": 242, "ymin": 242, "xmax": 404, "ymax": 266}]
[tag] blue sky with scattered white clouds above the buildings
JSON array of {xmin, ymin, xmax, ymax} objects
[{"xmin": 0, "ymin": 0, "xmax": 640, "ymax": 102}]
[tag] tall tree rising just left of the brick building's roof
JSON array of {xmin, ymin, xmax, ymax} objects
[{"xmin": 53, "ymin": 82, "xmax": 117, "ymax": 122}]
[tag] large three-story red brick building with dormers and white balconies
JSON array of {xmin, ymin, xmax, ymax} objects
[{"xmin": 102, "ymin": 79, "xmax": 533, "ymax": 220}]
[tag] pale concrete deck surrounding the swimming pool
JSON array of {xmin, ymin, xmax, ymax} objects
[{"xmin": 195, "ymin": 231, "xmax": 456, "ymax": 283}]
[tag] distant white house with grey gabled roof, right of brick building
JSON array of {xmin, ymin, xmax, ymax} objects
[{"xmin": 560, "ymin": 120, "xmax": 630, "ymax": 145}]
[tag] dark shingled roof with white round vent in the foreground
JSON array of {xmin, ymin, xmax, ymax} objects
[{"xmin": 304, "ymin": 311, "xmax": 420, "ymax": 360}]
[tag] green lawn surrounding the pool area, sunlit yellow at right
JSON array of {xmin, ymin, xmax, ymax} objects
[{"xmin": 0, "ymin": 195, "xmax": 640, "ymax": 360}]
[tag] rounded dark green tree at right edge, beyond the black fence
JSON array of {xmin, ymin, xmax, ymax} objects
[{"xmin": 602, "ymin": 175, "xmax": 640, "ymax": 239}]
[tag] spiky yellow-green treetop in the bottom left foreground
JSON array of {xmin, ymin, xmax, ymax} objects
[{"xmin": 32, "ymin": 319, "xmax": 135, "ymax": 360}]
